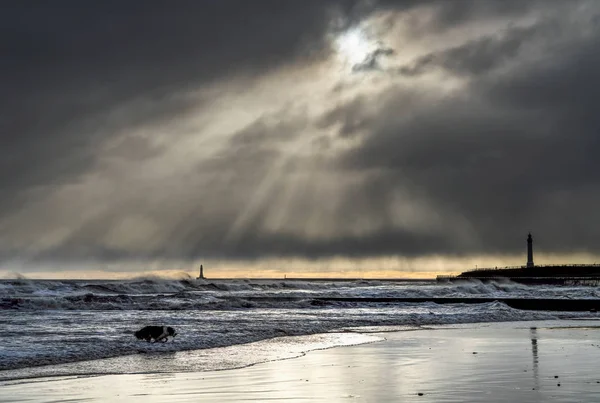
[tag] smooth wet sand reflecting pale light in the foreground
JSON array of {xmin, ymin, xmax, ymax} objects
[{"xmin": 0, "ymin": 321, "xmax": 600, "ymax": 402}]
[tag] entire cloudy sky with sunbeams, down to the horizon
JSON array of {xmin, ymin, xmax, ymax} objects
[{"xmin": 0, "ymin": 0, "xmax": 600, "ymax": 277}]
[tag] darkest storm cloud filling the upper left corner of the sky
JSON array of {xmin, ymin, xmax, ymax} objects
[{"xmin": 0, "ymin": 0, "xmax": 364, "ymax": 202}]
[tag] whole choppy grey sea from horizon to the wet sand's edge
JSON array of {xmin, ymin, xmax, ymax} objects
[{"xmin": 0, "ymin": 277, "xmax": 600, "ymax": 382}]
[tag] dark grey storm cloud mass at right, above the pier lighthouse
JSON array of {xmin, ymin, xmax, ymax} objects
[{"xmin": 338, "ymin": 3, "xmax": 600, "ymax": 253}]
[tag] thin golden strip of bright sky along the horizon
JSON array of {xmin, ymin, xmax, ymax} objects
[{"xmin": 0, "ymin": 253, "xmax": 600, "ymax": 280}]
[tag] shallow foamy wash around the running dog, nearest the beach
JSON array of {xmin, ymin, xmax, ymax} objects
[{"xmin": 0, "ymin": 302, "xmax": 564, "ymax": 379}]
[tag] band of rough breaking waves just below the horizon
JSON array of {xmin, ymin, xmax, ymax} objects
[{"xmin": 0, "ymin": 278, "xmax": 600, "ymax": 311}]
